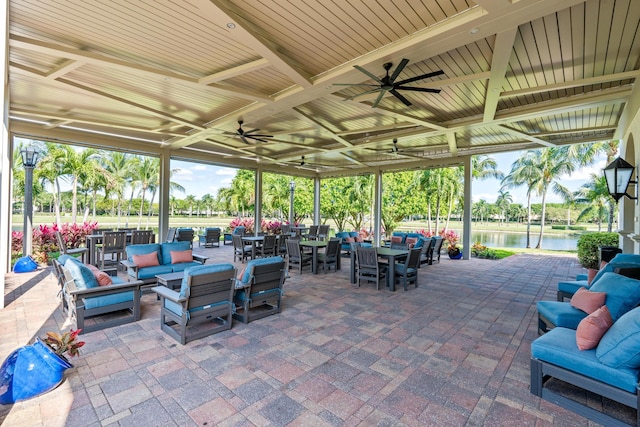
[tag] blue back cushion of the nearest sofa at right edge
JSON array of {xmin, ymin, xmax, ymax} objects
[{"xmin": 596, "ymin": 308, "xmax": 640, "ymax": 369}]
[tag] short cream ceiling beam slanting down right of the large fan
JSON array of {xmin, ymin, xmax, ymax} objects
[{"xmin": 483, "ymin": 28, "xmax": 517, "ymax": 122}]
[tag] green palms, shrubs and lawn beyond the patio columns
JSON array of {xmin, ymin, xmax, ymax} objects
[{"xmin": 13, "ymin": 141, "xmax": 617, "ymax": 260}]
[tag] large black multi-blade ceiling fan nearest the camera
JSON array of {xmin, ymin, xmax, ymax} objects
[{"xmin": 335, "ymin": 58, "xmax": 444, "ymax": 108}]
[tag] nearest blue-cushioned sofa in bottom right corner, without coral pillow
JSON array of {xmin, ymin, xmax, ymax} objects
[{"xmin": 530, "ymin": 308, "xmax": 640, "ymax": 426}]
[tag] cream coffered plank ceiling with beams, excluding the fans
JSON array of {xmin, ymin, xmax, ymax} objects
[{"xmin": 9, "ymin": 0, "xmax": 640, "ymax": 176}]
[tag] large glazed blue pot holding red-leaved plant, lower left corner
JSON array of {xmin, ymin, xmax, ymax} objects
[{"xmin": 0, "ymin": 338, "xmax": 73, "ymax": 405}]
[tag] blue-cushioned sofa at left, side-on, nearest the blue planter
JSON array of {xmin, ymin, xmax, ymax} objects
[{"xmin": 56, "ymin": 255, "xmax": 142, "ymax": 333}]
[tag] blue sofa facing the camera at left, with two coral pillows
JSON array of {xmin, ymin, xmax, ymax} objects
[{"xmin": 121, "ymin": 241, "xmax": 208, "ymax": 284}]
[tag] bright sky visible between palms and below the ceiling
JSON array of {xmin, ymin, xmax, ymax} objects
[{"xmin": 171, "ymin": 151, "xmax": 606, "ymax": 206}]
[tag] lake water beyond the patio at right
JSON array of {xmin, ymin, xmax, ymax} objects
[{"xmin": 464, "ymin": 231, "xmax": 579, "ymax": 250}]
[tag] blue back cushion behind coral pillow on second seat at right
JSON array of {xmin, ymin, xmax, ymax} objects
[{"xmin": 589, "ymin": 273, "xmax": 640, "ymax": 322}]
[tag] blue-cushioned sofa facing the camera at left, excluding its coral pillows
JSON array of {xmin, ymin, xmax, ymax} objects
[{"xmin": 121, "ymin": 241, "xmax": 208, "ymax": 284}]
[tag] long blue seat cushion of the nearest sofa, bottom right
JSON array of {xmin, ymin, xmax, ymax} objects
[{"xmin": 531, "ymin": 328, "xmax": 640, "ymax": 394}]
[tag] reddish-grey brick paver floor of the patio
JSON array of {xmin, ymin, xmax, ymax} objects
[{"xmin": 0, "ymin": 246, "xmax": 634, "ymax": 426}]
